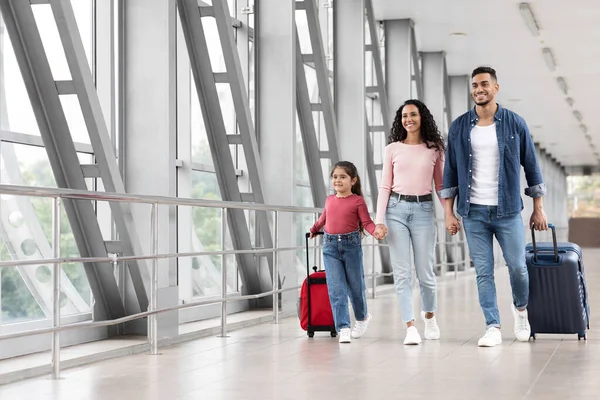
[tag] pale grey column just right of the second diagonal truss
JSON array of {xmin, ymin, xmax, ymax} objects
[{"xmin": 255, "ymin": 0, "xmax": 304, "ymax": 310}]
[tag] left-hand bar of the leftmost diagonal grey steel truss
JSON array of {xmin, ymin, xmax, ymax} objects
[{"xmin": 0, "ymin": 0, "xmax": 125, "ymax": 318}]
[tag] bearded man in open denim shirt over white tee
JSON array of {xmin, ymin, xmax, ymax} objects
[{"xmin": 440, "ymin": 67, "xmax": 548, "ymax": 347}]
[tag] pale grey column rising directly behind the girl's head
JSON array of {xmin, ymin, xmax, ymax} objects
[{"xmin": 333, "ymin": 0, "xmax": 367, "ymax": 173}]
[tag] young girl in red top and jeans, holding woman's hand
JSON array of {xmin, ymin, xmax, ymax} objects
[{"xmin": 310, "ymin": 161, "xmax": 375, "ymax": 343}]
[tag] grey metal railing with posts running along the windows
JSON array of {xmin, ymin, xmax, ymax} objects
[{"xmin": 0, "ymin": 184, "xmax": 474, "ymax": 378}]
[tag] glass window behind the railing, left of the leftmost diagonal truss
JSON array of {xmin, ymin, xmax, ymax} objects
[{"xmin": 0, "ymin": 143, "xmax": 91, "ymax": 322}]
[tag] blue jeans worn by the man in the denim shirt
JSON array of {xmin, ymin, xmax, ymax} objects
[{"xmin": 463, "ymin": 204, "xmax": 529, "ymax": 328}]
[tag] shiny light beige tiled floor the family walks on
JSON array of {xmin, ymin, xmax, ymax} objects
[{"xmin": 0, "ymin": 250, "xmax": 600, "ymax": 400}]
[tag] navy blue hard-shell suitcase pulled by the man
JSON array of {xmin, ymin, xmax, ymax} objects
[{"xmin": 525, "ymin": 224, "xmax": 589, "ymax": 340}]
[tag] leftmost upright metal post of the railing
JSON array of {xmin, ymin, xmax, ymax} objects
[{"xmin": 52, "ymin": 197, "xmax": 61, "ymax": 379}]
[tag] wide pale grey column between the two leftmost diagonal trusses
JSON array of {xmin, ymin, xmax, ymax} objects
[{"xmin": 124, "ymin": 0, "xmax": 178, "ymax": 337}]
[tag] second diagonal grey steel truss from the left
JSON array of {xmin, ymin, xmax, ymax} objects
[{"xmin": 177, "ymin": 0, "xmax": 272, "ymax": 293}]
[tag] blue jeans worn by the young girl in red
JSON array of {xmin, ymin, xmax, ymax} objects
[{"xmin": 323, "ymin": 231, "xmax": 367, "ymax": 332}]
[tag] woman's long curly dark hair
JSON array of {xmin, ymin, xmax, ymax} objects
[{"xmin": 388, "ymin": 99, "xmax": 446, "ymax": 153}]
